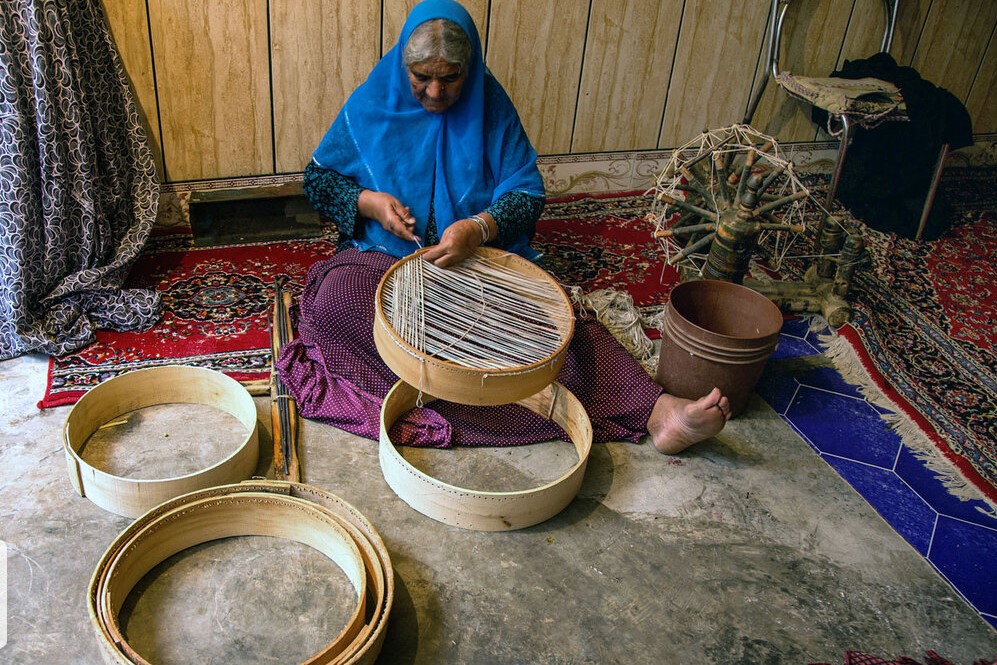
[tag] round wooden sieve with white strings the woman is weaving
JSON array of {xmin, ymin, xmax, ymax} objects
[{"xmin": 374, "ymin": 247, "xmax": 574, "ymax": 404}]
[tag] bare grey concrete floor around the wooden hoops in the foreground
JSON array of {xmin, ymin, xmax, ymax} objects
[{"xmin": 0, "ymin": 356, "xmax": 997, "ymax": 665}]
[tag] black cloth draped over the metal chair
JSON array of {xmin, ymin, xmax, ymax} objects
[{"xmin": 811, "ymin": 53, "xmax": 973, "ymax": 240}]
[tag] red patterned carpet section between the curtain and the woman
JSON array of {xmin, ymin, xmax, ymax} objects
[{"xmin": 38, "ymin": 233, "xmax": 336, "ymax": 408}]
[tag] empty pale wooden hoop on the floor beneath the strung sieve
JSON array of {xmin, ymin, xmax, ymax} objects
[{"xmin": 378, "ymin": 381, "xmax": 592, "ymax": 531}]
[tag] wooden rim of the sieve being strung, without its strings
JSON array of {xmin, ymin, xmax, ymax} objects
[{"xmin": 374, "ymin": 247, "xmax": 575, "ymax": 405}]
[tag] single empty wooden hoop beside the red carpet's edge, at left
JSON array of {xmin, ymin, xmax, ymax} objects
[{"xmin": 62, "ymin": 365, "xmax": 260, "ymax": 517}]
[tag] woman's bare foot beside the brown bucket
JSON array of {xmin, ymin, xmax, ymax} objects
[{"xmin": 647, "ymin": 388, "xmax": 730, "ymax": 455}]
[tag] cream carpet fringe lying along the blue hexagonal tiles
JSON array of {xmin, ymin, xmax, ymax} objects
[{"xmin": 818, "ymin": 332, "xmax": 997, "ymax": 510}]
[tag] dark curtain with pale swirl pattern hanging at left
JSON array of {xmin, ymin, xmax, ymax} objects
[{"xmin": 0, "ymin": 0, "xmax": 159, "ymax": 360}]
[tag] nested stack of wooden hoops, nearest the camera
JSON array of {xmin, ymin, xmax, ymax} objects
[{"xmin": 88, "ymin": 481, "xmax": 394, "ymax": 665}]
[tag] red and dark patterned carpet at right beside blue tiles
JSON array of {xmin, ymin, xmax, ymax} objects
[{"xmin": 831, "ymin": 211, "xmax": 997, "ymax": 502}]
